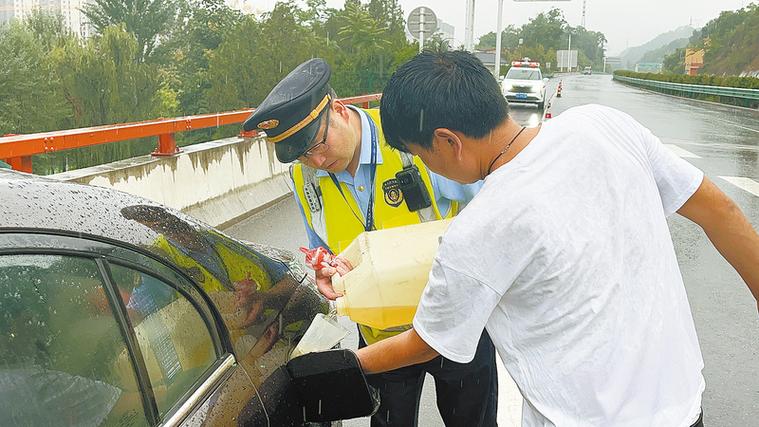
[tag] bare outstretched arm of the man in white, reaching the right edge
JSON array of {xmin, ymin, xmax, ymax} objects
[{"xmin": 677, "ymin": 177, "xmax": 759, "ymax": 310}]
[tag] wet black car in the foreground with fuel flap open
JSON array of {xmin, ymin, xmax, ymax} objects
[{"xmin": 0, "ymin": 169, "xmax": 378, "ymax": 426}]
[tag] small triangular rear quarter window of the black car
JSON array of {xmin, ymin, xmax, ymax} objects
[{"xmin": 111, "ymin": 264, "xmax": 216, "ymax": 416}]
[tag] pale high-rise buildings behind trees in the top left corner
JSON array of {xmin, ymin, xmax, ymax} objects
[{"xmin": 0, "ymin": 0, "xmax": 92, "ymax": 37}]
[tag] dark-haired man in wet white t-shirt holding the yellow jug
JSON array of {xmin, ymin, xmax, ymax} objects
[{"xmin": 342, "ymin": 52, "xmax": 759, "ymax": 427}]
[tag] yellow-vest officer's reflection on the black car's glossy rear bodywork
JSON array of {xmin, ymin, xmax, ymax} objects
[{"xmin": 121, "ymin": 205, "xmax": 302, "ymax": 384}]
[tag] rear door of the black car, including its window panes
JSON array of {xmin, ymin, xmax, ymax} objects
[{"xmin": 0, "ymin": 230, "xmax": 268, "ymax": 426}]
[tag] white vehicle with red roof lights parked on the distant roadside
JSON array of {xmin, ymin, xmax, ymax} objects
[{"xmin": 501, "ymin": 58, "xmax": 548, "ymax": 110}]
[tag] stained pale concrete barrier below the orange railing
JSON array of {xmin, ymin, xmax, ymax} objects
[{"xmin": 49, "ymin": 137, "xmax": 290, "ymax": 227}]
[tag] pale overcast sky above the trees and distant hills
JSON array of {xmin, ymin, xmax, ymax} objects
[{"xmin": 248, "ymin": 0, "xmax": 751, "ymax": 56}]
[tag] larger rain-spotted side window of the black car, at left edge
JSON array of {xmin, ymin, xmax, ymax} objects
[{"xmin": 0, "ymin": 255, "xmax": 147, "ymax": 426}]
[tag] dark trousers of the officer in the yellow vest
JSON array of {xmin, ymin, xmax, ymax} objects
[{"xmin": 358, "ymin": 332, "xmax": 498, "ymax": 427}]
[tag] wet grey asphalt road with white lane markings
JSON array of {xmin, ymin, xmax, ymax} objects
[{"xmin": 226, "ymin": 75, "xmax": 759, "ymax": 426}]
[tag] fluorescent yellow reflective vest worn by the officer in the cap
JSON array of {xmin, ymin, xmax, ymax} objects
[{"xmin": 291, "ymin": 109, "xmax": 458, "ymax": 344}]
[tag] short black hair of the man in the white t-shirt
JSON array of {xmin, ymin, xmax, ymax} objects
[{"xmin": 380, "ymin": 50, "xmax": 509, "ymax": 151}]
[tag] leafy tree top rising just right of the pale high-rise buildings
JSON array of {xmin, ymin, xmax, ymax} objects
[{"xmin": 82, "ymin": 0, "xmax": 178, "ymax": 61}]
